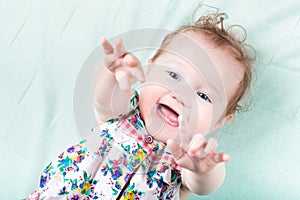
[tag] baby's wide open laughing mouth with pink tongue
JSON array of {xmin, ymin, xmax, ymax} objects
[{"xmin": 157, "ymin": 104, "xmax": 179, "ymax": 127}]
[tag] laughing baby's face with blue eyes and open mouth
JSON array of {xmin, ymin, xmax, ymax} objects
[{"xmin": 140, "ymin": 32, "xmax": 243, "ymax": 142}]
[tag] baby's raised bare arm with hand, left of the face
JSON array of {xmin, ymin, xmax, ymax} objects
[{"xmin": 94, "ymin": 38, "xmax": 144, "ymax": 122}]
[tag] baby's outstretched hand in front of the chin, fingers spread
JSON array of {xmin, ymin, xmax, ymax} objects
[{"xmin": 167, "ymin": 115, "xmax": 230, "ymax": 174}]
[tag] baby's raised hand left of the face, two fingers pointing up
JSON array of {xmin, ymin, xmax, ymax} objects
[{"xmin": 101, "ymin": 38, "xmax": 145, "ymax": 91}]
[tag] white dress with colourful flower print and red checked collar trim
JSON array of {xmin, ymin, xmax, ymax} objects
[{"xmin": 38, "ymin": 92, "xmax": 181, "ymax": 200}]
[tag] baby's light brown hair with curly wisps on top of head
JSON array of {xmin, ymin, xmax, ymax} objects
[{"xmin": 152, "ymin": 13, "xmax": 255, "ymax": 116}]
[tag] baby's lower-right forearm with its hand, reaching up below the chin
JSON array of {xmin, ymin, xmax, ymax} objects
[{"xmin": 168, "ymin": 117, "xmax": 230, "ymax": 195}]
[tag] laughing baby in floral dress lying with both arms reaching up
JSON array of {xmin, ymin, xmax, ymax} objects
[{"xmin": 28, "ymin": 13, "xmax": 252, "ymax": 199}]
